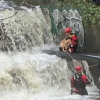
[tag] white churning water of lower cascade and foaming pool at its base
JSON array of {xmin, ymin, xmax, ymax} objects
[{"xmin": 0, "ymin": 45, "xmax": 98, "ymax": 100}]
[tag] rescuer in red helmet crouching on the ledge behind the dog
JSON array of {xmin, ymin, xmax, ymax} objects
[{"xmin": 65, "ymin": 27, "xmax": 78, "ymax": 52}]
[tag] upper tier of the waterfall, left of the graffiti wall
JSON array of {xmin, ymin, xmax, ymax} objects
[{"xmin": 0, "ymin": 2, "xmax": 53, "ymax": 52}]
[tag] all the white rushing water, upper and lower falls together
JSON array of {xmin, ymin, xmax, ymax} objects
[{"xmin": 0, "ymin": 1, "xmax": 98, "ymax": 100}]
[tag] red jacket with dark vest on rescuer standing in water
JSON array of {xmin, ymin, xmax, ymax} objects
[{"xmin": 71, "ymin": 74, "xmax": 91, "ymax": 88}]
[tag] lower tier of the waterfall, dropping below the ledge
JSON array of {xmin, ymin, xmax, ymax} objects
[{"xmin": 0, "ymin": 53, "xmax": 70, "ymax": 93}]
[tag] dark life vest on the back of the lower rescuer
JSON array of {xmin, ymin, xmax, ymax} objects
[{"xmin": 73, "ymin": 73, "xmax": 86, "ymax": 88}]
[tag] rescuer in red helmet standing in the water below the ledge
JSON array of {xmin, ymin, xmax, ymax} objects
[{"xmin": 71, "ymin": 66, "xmax": 91, "ymax": 95}]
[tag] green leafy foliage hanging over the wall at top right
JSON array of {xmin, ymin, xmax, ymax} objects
[{"xmin": 58, "ymin": 0, "xmax": 100, "ymax": 26}]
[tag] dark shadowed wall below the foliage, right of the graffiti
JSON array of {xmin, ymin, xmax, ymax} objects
[{"xmin": 83, "ymin": 23, "xmax": 100, "ymax": 54}]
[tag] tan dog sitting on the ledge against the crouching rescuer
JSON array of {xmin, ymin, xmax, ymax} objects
[{"xmin": 59, "ymin": 37, "xmax": 72, "ymax": 52}]
